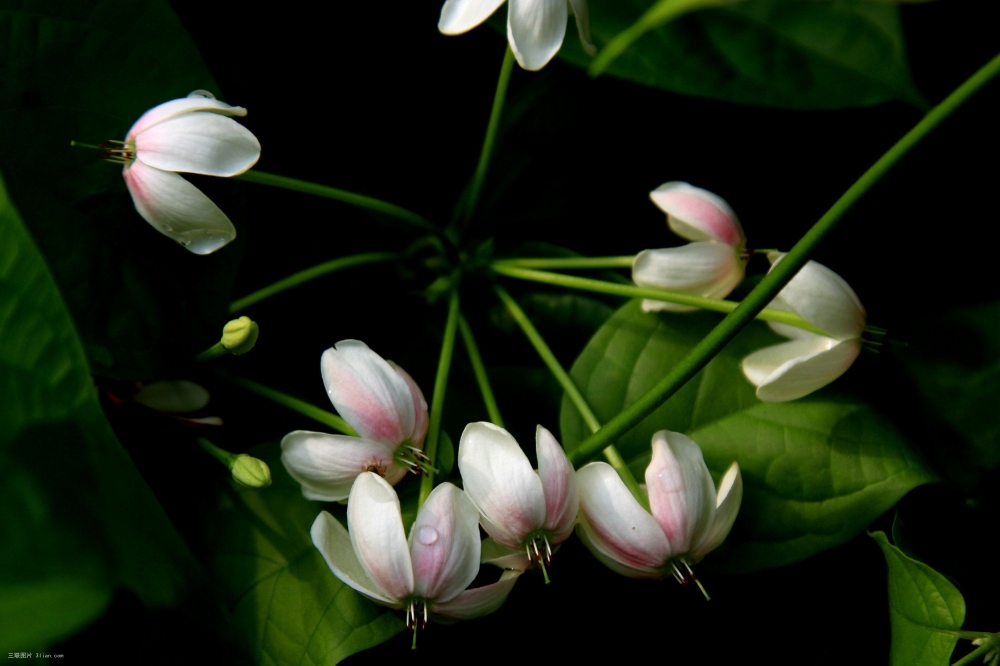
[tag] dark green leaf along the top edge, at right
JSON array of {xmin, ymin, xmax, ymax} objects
[{"xmin": 559, "ymin": 0, "xmax": 925, "ymax": 109}]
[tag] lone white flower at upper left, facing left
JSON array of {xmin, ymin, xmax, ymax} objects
[{"xmin": 108, "ymin": 90, "xmax": 260, "ymax": 254}]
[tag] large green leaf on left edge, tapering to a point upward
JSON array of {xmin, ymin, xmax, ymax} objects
[{"xmin": 0, "ymin": 169, "xmax": 203, "ymax": 653}]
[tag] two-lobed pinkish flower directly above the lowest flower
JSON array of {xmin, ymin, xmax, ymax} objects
[{"xmin": 281, "ymin": 340, "xmax": 427, "ymax": 502}]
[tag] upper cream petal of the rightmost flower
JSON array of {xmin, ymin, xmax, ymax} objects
[{"xmin": 768, "ymin": 253, "xmax": 865, "ymax": 340}]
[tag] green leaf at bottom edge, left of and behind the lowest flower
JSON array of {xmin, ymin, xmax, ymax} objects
[{"xmin": 207, "ymin": 443, "xmax": 405, "ymax": 666}]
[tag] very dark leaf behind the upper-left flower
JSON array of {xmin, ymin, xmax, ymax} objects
[{"xmin": 0, "ymin": 0, "xmax": 239, "ymax": 379}]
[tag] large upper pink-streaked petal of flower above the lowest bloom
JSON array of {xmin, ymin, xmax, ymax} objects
[{"xmin": 320, "ymin": 340, "xmax": 416, "ymax": 447}]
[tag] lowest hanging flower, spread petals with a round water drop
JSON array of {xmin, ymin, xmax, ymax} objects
[{"xmin": 311, "ymin": 472, "xmax": 520, "ymax": 631}]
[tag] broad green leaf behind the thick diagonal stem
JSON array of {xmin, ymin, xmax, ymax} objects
[{"xmin": 560, "ymin": 301, "xmax": 934, "ymax": 571}]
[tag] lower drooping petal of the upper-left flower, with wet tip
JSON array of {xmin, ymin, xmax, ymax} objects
[{"xmin": 122, "ymin": 160, "xmax": 236, "ymax": 254}]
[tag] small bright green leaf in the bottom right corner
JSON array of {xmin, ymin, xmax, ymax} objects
[{"xmin": 871, "ymin": 532, "xmax": 965, "ymax": 666}]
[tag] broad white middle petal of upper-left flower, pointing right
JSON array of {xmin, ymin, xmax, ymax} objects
[{"xmin": 135, "ymin": 112, "xmax": 260, "ymax": 176}]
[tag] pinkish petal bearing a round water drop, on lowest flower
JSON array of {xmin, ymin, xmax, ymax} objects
[{"xmin": 409, "ymin": 482, "xmax": 481, "ymax": 602}]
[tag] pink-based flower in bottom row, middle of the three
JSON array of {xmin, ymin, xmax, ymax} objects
[{"xmin": 458, "ymin": 422, "xmax": 579, "ymax": 565}]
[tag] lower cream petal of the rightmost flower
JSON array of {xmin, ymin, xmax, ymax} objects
[{"xmin": 743, "ymin": 335, "xmax": 861, "ymax": 402}]
